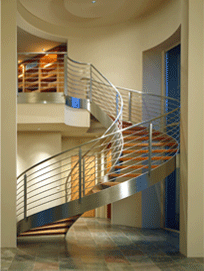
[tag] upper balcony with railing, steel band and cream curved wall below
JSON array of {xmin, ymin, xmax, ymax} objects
[{"xmin": 17, "ymin": 45, "xmax": 93, "ymax": 135}]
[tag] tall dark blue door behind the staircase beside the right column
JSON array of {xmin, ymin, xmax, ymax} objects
[{"xmin": 165, "ymin": 45, "xmax": 180, "ymax": 230}]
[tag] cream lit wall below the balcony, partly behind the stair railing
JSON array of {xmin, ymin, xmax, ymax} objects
[{"xmin": 17, "ymin": 132, "xmax": 64, "ymax": 221}]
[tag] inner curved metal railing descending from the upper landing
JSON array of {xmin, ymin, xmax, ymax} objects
[{"xmin": 65, "ymin": 58, "xmax": 123, "ymax": 202}]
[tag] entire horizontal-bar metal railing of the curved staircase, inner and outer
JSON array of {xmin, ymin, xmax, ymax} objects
[{"xmin": 17, "ymin": 56, "xmax": 180, "ymax": 234}]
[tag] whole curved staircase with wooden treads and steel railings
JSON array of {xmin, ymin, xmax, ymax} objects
[{"xmin": 17, "ymin": 58, "xmax": 180, "ymax": 236}]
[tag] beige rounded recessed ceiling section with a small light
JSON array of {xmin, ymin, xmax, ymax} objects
[{"xmin": 19, "ymin": 0, "xmax": 170, "ymax": 28}]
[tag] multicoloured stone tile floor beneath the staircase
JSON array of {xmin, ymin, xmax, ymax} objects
[{"xmin": 1, "ymin": 218, "xmax": 204, "ymax": 271}]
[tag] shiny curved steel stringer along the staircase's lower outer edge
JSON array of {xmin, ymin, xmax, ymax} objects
[{"xmin": 17, "ymin": 155, "xmax": 176, "ymax": 235}]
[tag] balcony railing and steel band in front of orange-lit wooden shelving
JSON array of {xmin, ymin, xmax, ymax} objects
[{"xmin": 18, "ymin": 45, "xmax": 67, "ymax": 103}]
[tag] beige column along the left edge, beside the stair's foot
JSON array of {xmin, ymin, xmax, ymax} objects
[{"xmin": 0, "ymin": 0, "xmax": 17, "ymax": 247}]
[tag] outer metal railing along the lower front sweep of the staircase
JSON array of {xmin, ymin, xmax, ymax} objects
[{"xmin": 17, "ymin": 97, "xmax": 179, "ymax": 221}]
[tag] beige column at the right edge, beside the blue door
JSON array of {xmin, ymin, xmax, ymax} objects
[{"xmin": 180, "ymin": 0, "xmax": 204, "ymax": 257}]
